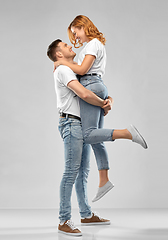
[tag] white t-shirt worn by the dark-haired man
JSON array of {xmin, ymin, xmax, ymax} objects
[{"xmin": 54, "ymin": 65, "xmax": 80, "ymax": 117}]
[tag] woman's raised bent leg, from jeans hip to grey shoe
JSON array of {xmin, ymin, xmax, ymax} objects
[{"xmin": 80, "ymin": 76, "xmax": 148, "ymax": 149}]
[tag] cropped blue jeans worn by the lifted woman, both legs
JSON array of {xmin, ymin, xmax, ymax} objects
[{"xmin": 80, "ymin": 76, "xmax": 114, "ymax": 170}]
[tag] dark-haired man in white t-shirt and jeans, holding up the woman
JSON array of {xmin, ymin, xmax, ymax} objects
[{"xmin": 47, "ymin": 39, "xmax": 111, "ymax": 236}]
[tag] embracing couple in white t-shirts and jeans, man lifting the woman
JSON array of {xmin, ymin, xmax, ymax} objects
[{"xmin": 47, "ymin": 15, "xmax": 147, "ymax": 236}]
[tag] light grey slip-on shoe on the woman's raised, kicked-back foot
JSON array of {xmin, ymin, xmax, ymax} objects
[{"xmin": 127, "ymin": 125, "xmax": 148, "ymax": 149}]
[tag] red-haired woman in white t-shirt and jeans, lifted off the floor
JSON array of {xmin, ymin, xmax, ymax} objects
[{"xmin": 54, "ymin": 15, "xmax": 147, "ymax": 202}]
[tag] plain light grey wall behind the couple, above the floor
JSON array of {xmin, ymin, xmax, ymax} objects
[{"xmin": 0, "ymin": 0, "xmax": 168, "ymax": 208}]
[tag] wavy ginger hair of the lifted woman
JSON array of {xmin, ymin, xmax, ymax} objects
[{"xmin": 68, "ymin": 15, "xmax": 106, "ymax": 48}]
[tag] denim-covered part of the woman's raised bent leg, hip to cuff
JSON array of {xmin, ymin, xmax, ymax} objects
[{"xmin": 80, "ymin": 76, "xmax": 114, "ymax": 144}]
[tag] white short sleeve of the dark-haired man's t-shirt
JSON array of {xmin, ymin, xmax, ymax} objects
[{"xmin": 58, "ymin": 66, "xmax": 77, "ymax": 86}]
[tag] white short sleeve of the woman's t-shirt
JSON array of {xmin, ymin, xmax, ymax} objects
[{"xmin": 85, "ymin": 39, "xmax": 101, "ymax": 58}]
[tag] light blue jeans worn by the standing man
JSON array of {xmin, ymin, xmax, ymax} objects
[{"xmin": 59, "ymin": 118, "xmax": 91, "ymax": 222}]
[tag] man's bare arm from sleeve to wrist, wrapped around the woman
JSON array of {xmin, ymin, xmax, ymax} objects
[{"xmin": 67, "ymin": 80, "xmax": 106, "ymax": 107}]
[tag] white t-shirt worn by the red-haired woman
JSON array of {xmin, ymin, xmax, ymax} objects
[{"xmin": 78, "ymin": 38, "xmax": 106, "ymax": 76}]
